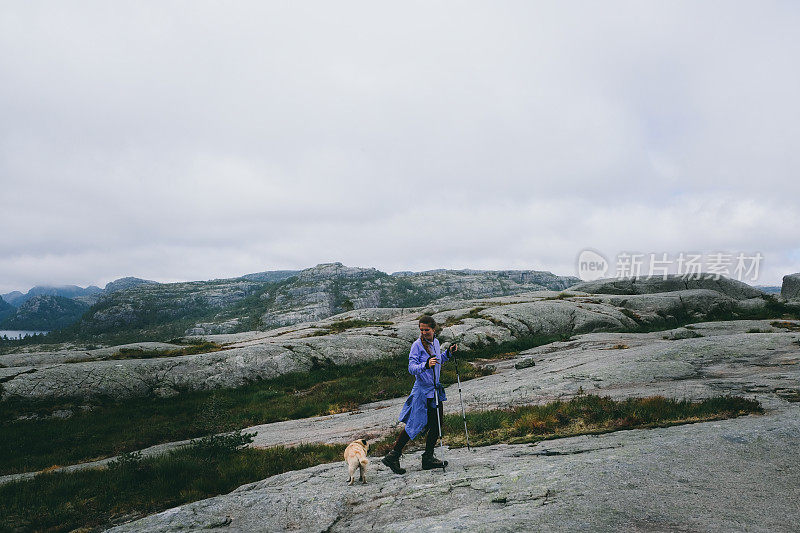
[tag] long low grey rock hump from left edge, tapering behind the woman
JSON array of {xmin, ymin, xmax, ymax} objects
[{"xmin": 0, "ymin": 335, "xmax": 406, "ymax": 399}]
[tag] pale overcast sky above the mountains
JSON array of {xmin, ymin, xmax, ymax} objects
[{"xmin": 0, "ymin": 0, "xmax": 800, "ymax": 292}]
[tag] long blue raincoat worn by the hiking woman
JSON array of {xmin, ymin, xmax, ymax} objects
[{"xmin": 398, "ymin": 338, "xmax": 450, "ymax": 439}]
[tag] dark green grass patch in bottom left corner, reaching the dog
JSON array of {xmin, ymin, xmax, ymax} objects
[{"xmin": 0, "ymin": 433, "xmax": 345, "ymax": 533}]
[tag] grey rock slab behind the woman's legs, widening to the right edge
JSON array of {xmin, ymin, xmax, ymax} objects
[{"xmin": 202, "ymin": 320, "xmax": 800, "ymax": 447}]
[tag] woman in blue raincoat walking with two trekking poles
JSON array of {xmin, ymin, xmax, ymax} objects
[{"xmin": 382, "ymin": 315, "xmax": 458, "ymax": 474}]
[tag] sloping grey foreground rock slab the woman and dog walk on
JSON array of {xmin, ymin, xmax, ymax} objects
[{"xmin": 110, "ymin": 406, "xmax": 800, "ymax": 532}]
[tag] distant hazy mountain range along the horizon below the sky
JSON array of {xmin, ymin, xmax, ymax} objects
[{"xmin": 0, "ymin": 263, "xmax": 580, "ymax": 342}]
